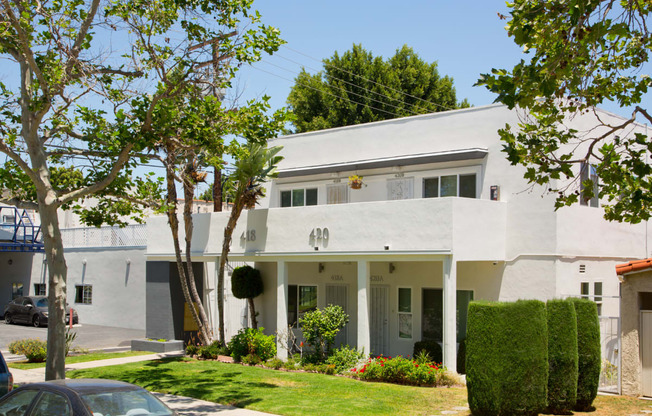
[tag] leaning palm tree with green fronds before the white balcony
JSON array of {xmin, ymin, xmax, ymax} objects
[{"xmin": 217, "ymin": 143, "xmax": 283, "ymax": 342}]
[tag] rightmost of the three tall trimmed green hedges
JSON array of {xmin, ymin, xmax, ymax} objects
[{"xmin": 572, "ymin": 299, "xmax": 601, "ymax": 411}]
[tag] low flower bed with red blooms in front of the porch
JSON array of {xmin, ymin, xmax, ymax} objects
[{"xmin": 350, "ymin": 356, "xmax": 460, "ymax": 386}]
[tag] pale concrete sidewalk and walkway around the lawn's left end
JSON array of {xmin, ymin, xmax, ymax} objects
[{"xmin": 9, "ymin": 351, "xmax": 270, "ymax": 416}]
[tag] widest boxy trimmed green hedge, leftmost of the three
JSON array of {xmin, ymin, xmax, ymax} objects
[{"xmin": 466, "ymin": 301, "xmax": 548, "ymax": 415}]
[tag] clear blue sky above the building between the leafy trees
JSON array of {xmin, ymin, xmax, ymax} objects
[{"xmin": 235, "ymin": 0, "xmax": 652, "ymax": 116}]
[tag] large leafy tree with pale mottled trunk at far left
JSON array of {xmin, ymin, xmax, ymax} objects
[{"xmin": 0, "ymin": 0, "xmax": 278, "ymax": 379}]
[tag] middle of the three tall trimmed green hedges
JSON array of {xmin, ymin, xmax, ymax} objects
[{"xmin": 546, "ymin": 299, "xmax": 578, "ymax": 414}]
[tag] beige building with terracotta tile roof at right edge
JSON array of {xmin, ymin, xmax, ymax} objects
[{"xmin": 616, "ymin": 258, "xmax": 652, "ymax": 397}]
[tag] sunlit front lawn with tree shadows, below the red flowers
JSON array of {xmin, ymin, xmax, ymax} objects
[{"xmin": 67, "ymin": 358, "xmax": 652, "ymax": 416}]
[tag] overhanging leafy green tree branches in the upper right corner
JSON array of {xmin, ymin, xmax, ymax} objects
[{"xmin": 478, "ymin": 0, "xmax": 652, "ymax": 223}]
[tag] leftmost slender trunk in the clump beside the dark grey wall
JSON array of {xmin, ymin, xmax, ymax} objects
[{"xmin": 165, "ymin": 151, "xmax": 210, "ymax": 345}]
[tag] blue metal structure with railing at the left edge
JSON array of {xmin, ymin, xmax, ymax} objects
[{"xmin": 0, "ymin": 206, "xmax": 45, "ymax": 253}]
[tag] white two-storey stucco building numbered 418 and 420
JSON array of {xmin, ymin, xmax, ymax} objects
[{"xmin": 146, "ymin": 105, "xmax": 649, "ymax": 369}]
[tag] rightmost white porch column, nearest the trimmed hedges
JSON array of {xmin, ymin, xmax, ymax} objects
[{"xmin": 443, "ymin": 256, "xmax": 457, "ymax": 371}]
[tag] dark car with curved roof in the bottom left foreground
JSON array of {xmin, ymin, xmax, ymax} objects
[{"xmin": 0, "ymin": 379, "xmax": 178, "ymax": 416}]
